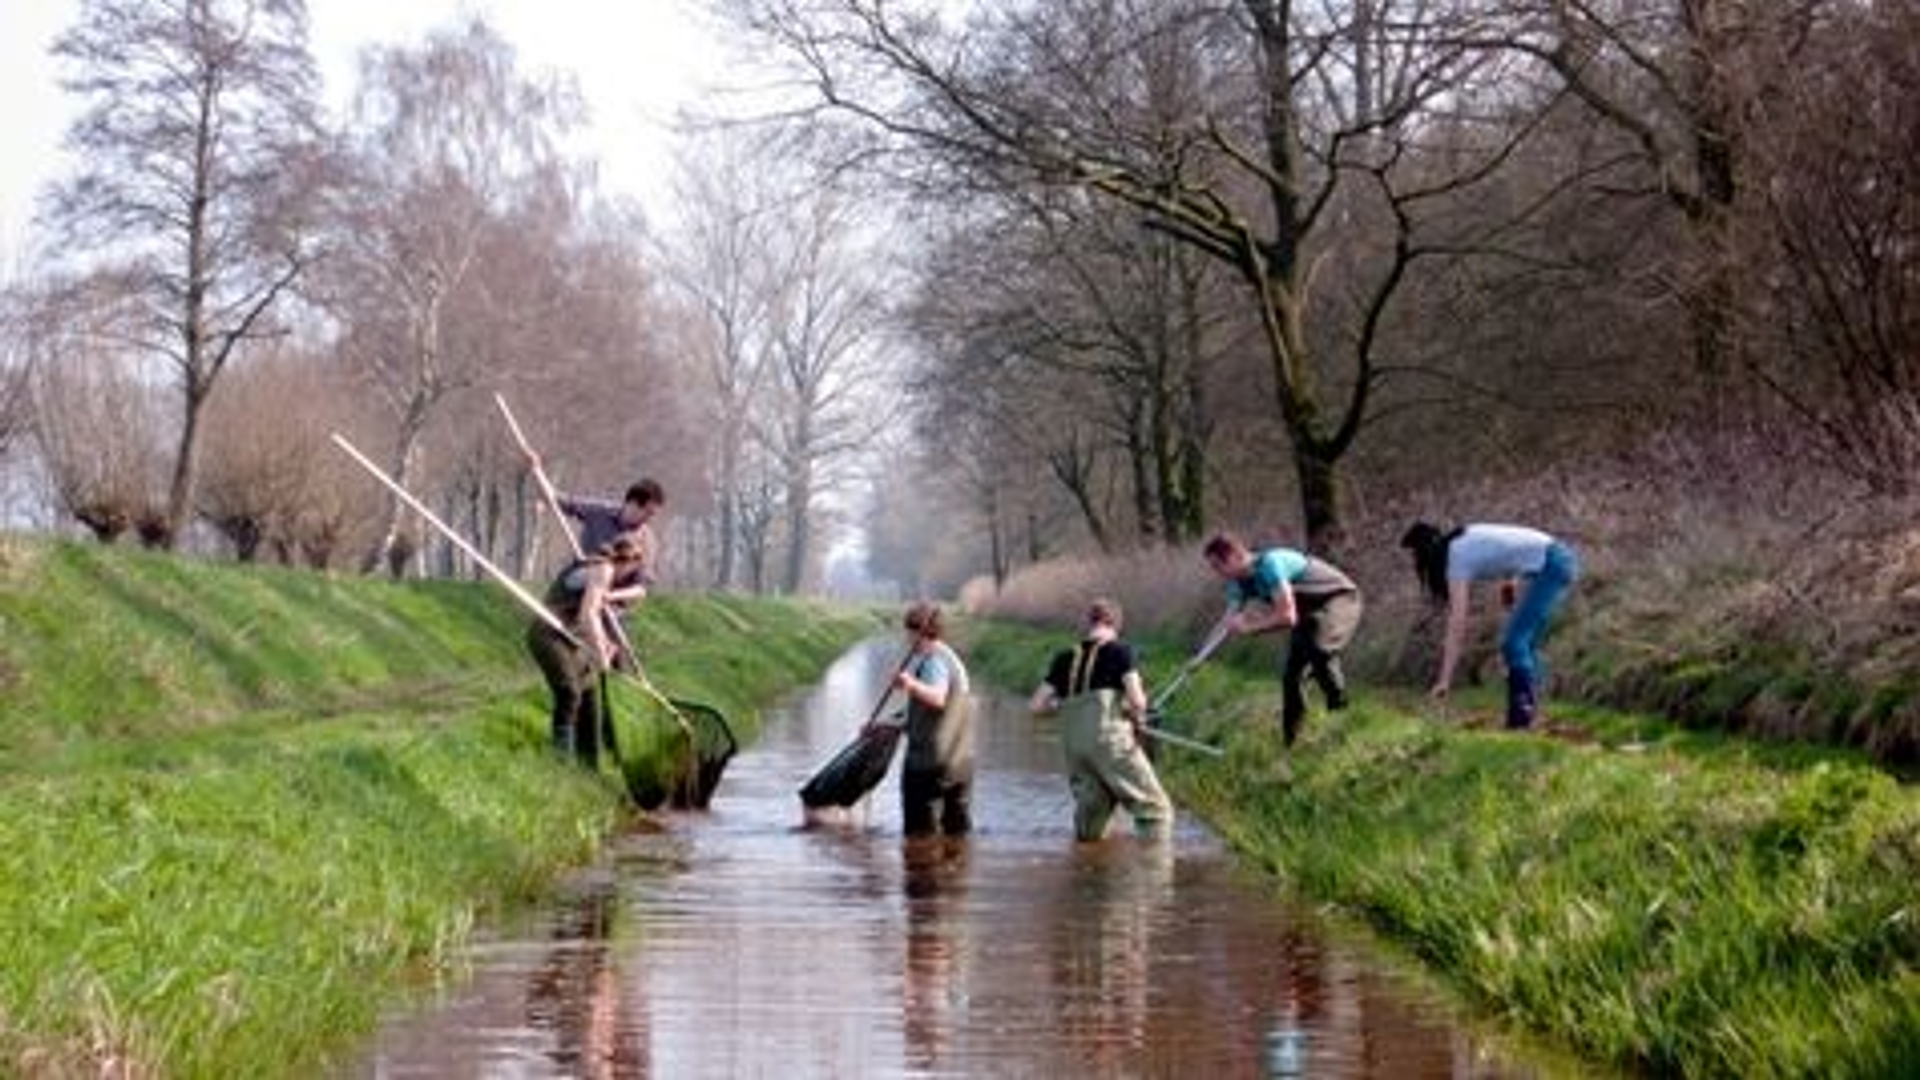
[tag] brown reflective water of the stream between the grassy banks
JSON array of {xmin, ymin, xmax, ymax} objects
[{"xmin": 340, "ymin": 642, "xmax": 1584, "ymax": 1080}]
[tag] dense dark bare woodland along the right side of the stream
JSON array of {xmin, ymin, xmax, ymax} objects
[{"xmin": 714, "ymin": 0, "xmax": 1920, "ymax": 588}]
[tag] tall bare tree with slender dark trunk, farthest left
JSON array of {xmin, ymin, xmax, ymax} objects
[{"xmin": 52, "ymin": 0, "xmax": 319, "ymax": 546}]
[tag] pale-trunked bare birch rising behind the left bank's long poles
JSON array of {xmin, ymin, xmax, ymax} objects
[{"xmin": 324, "ymin": 19, "xmax": 578, "ymax": 569}]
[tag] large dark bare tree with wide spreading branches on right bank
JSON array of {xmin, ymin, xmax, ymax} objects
[{"xmin": 728, "ymin": 0, "xmax": 1524, "ymax": 546}]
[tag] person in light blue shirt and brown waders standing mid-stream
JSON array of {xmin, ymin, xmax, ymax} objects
[{"xmin": 874, "ymin": 601, "xmax": 973, "ymax": 836}]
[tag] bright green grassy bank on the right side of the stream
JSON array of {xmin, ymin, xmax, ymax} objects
[{"xmin": 966, "ymin": 623, "xmax": 1920, "ymax": 1076}]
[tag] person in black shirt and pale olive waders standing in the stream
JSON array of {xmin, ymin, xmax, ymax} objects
[{"xmin": 1027, "ymin": 598, "xmax": 1173, "ymax": 842}]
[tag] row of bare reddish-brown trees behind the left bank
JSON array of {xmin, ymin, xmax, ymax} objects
[{"xmin": 0, "ymin": 0, "xmax": 883, "ymax": 590}]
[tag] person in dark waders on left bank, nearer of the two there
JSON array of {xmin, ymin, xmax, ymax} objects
[{"xmin": 526, "ymin": 534, "xmax": 647, "ymax": 769}]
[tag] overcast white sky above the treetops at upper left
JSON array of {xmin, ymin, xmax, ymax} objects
[{"xmin": 0, "ymin": 0, "xmax": 724, "ymax": 254}]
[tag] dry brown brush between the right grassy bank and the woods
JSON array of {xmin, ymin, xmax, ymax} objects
[{"xmin": 966, "ymin": 424, "xmax": 1920, "ymax": 767}]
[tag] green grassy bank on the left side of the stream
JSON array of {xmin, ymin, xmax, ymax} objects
[{"xmin": 0, "ymin": 536, "xmax": 870, "ymax": 1076}]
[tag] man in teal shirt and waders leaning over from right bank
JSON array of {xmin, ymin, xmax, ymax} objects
[{"xmin": 1202, "ymin": 532, "xmax": 1361, "ymax": 748}]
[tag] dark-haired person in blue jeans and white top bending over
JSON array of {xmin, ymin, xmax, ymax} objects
[{"xmin": 1400, "ymin": 521, "xmax": 1580, "ymax": 728}]
